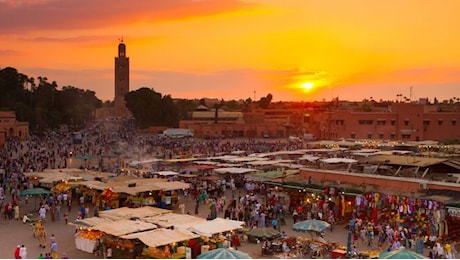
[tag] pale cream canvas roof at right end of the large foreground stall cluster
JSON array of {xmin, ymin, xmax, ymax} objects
[{"xmin": 188, "ymin": 218, "xmax": 244, "ymax": 237}]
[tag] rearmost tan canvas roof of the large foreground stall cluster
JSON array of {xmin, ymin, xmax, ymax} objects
[{"xmin": 99, "ymin": 206, "xmax": 171, "ymax": 220}]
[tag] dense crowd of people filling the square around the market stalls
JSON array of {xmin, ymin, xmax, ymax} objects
[{"xmin": 0, "ymin": 117, "xmax": 456, "ymax": 259}]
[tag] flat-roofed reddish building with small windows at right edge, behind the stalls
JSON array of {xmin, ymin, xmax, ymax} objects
[{"xmin": 308, "ymin": 103, "xmax": 460, "ymax": 141}]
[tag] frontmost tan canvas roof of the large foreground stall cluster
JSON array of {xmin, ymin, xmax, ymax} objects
[{"xmin": 121, "ymin": 228, "xmax": 199, "ymax": 247}]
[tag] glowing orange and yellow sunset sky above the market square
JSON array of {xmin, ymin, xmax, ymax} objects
[{"xmin": 0, "ymin": 0, "xmax": 460, "ymax": 101}]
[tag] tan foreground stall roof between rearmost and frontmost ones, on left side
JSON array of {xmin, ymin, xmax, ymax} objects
[{"xmin": 92, "ymin": 219, "xmax": 157, "ymax": 236}]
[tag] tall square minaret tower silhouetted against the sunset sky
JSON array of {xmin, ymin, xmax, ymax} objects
[{"xmin": 114, "ymin": 38, "xmax": 131, "ymax": 117}]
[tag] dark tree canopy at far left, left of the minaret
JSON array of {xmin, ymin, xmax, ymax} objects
[{"xmin": 0, "ymin": 67, "xmax": 102, "ymax": 131}]
